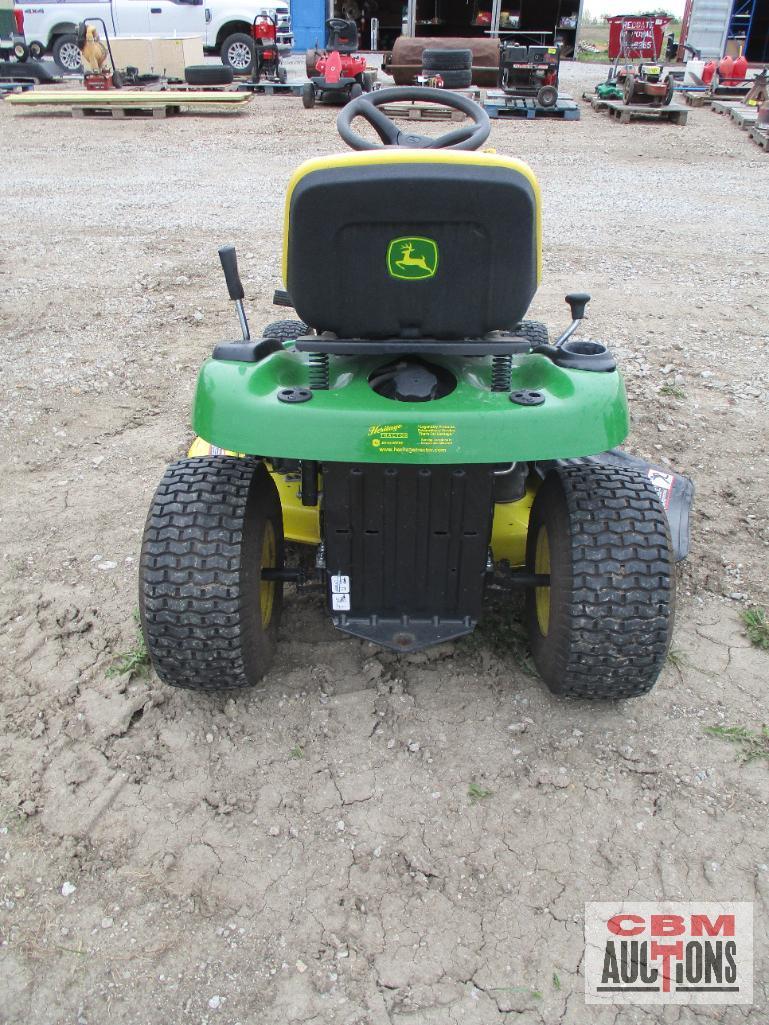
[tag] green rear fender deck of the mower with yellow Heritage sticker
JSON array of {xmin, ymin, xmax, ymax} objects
[{"xmin": 193, "ymin": 343, "xmax": 629, "ymax": 463}]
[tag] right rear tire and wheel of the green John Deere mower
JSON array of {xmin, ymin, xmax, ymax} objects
[{"xmin": 525, "ymin": 463, "xmax": 675, "ymax": 699}]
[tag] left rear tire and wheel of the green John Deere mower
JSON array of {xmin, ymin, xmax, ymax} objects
[{"xmin": 139, "ymin": 456, "xmax": 283, "ymax": 691}]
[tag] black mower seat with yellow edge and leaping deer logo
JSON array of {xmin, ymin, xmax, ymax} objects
[{"xmin": 283, "ymin": 149, "xmax": 541, "ymax": 339}]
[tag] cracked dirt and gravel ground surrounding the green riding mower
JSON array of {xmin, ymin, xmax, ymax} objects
[{"xmin": 0, "ymin": 66, "xmax": 769, "ymax": 1025}]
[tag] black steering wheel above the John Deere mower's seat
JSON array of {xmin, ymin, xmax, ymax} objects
[{"xmin": 336, "ymin": 85, "xmax": 491, "ymax": 150}]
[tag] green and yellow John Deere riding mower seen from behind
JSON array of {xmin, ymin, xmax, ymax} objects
[{"xmin": 140, "ymin": 87, "xmax": 691, "ymax": 698}]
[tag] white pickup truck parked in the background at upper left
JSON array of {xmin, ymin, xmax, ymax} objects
[{"xmin": 16, "ymin": 0, "xmax": 293, "ymax": 72}]
